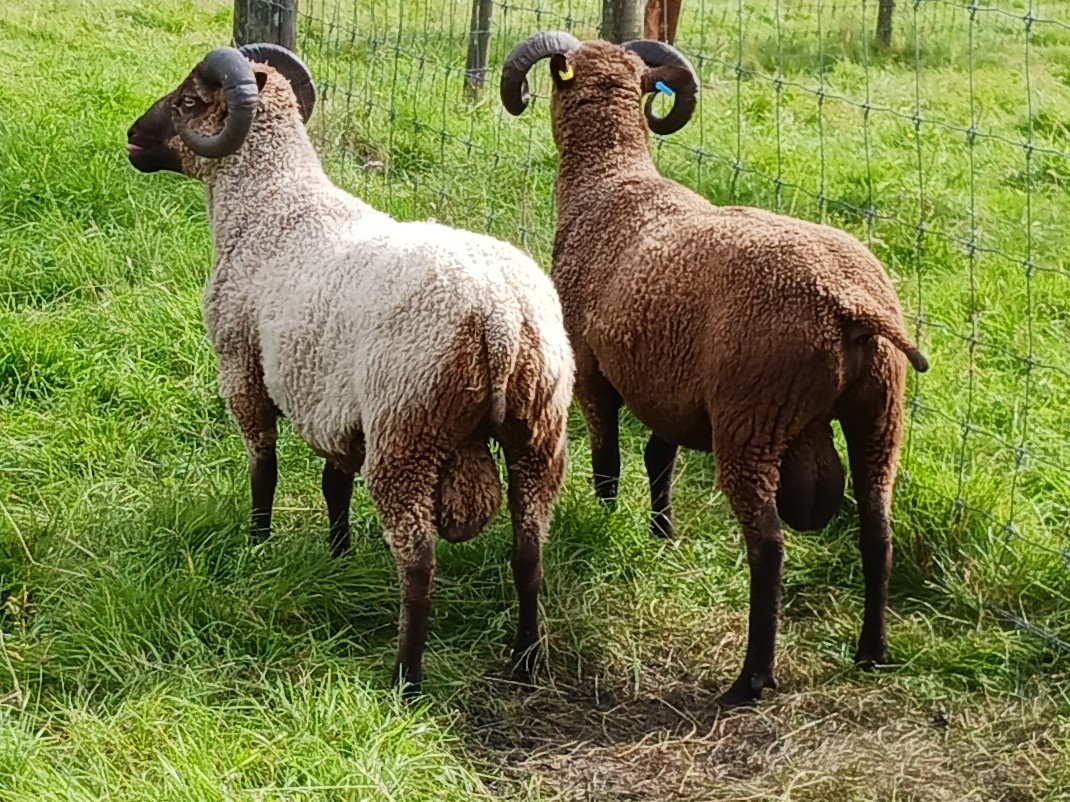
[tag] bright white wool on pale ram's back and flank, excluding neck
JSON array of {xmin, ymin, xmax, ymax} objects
[{"xmin": 250, "ymin": 215, "xmax": 570, "ymax": 453}]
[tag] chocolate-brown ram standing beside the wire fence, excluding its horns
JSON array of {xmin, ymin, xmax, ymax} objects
[{"xmin": 535, "ymin": 42, "xmax": 928, "ymax": 704}]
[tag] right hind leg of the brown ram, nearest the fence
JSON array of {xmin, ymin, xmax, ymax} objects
[{"xmin": 839, "ymin": 341, "xmax": 905, "ymax": 667}]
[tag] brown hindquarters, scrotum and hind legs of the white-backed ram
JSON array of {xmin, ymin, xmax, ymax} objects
[{"xmin": 363, "ymin": 318, "xmax": 570, "ymax": 688}]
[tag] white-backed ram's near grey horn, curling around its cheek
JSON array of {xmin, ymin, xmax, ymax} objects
[{"xmin": 179, "ymin": 47, "xmax": 259, "ymax": 158}]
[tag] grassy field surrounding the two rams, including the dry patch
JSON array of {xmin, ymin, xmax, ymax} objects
[{"xmin": 0, "ymin": 0, "xmax": 1070, "ymax": 802}]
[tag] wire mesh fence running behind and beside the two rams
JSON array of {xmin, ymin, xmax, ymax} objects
[{"xmin": 284, "ymin": 0, "xmax": 1070, "ymax": 650}]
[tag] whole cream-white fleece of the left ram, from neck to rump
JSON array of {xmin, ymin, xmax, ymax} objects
[{"xmin": 197, "ymin": 76, "xmax": 574, "ymax": 470}]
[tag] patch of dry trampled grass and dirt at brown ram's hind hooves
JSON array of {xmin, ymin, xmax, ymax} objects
[{"xmin": 461, "ymin": 679, "xmax": 1070, "ymax": 802}]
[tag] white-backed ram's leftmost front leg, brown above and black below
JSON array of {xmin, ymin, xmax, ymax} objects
[{"xmin": 227, "ymin": 389, "xmax": 278, "ymax": 540}]
